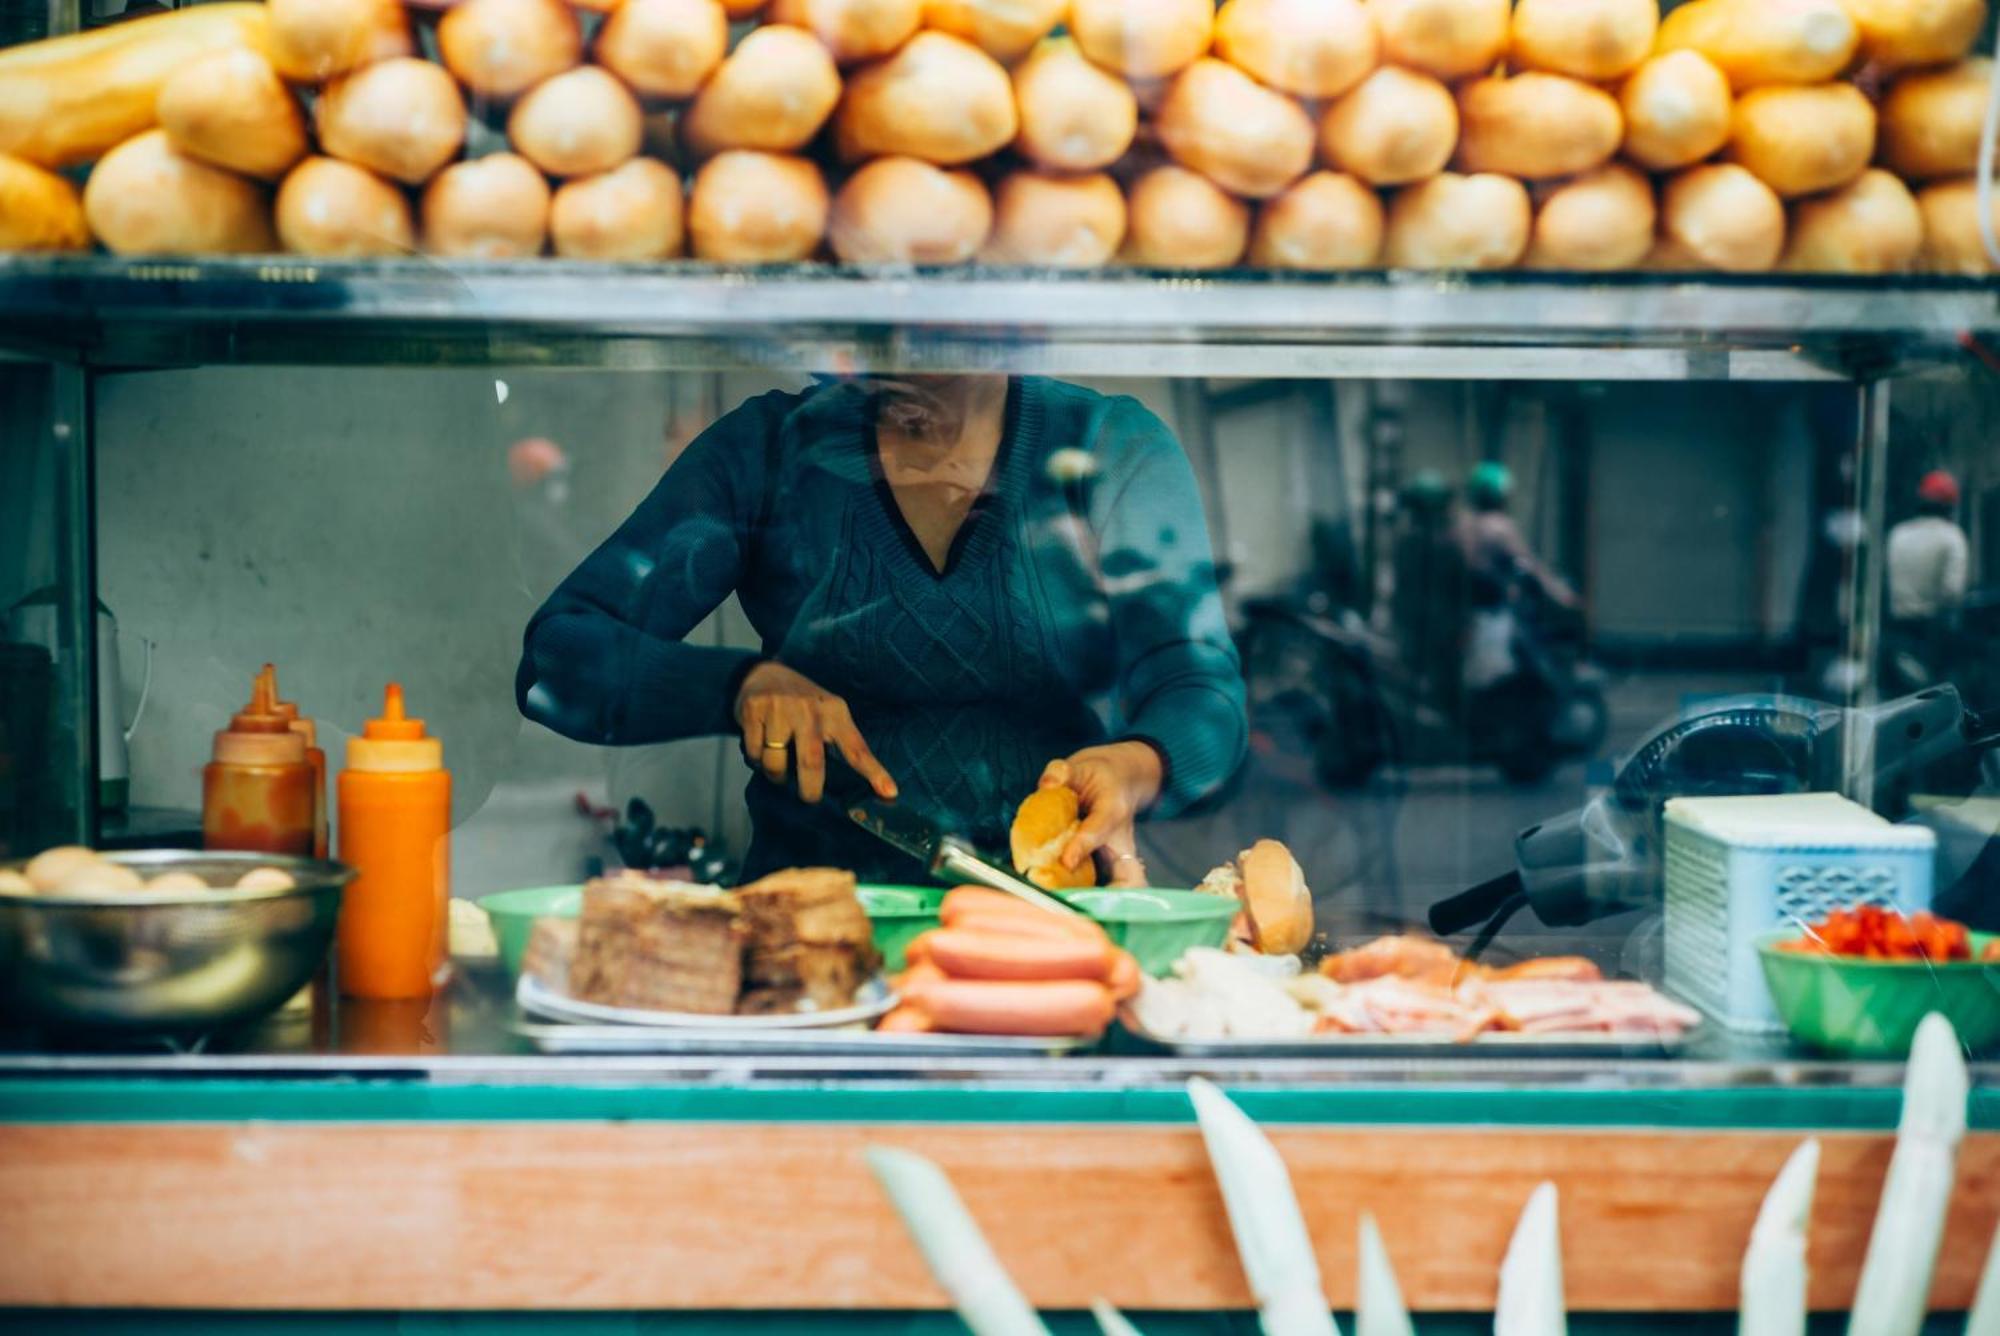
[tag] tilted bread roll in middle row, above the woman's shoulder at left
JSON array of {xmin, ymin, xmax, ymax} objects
[{"xmin": 680, "ymin": 24, "xmax": 840, "ymax": 158}]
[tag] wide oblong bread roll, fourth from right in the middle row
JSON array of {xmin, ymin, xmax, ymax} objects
[{"xmin": 1458, "ymin": 74, "xmax": 1624, "ymax": 180}]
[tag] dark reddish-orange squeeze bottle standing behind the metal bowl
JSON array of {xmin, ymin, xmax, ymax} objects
[{"xmin": 202, "ymin": 664, "xmax": 312, "ymax": 858}]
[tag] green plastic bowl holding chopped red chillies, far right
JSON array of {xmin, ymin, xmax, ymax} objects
[{"xmin": 1756, "ymin": 928, "xmax": 2000, "ymax": 1058}]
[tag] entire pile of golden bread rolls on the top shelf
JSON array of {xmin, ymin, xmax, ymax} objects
[{"xmin": 0, "ymin": 0, "xmax": 1990, "ymax": 274}]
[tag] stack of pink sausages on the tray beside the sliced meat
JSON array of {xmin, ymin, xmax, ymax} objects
[{"xmin": 878, "ymin": 886, "xmax": 1140, "ymax": 1036}]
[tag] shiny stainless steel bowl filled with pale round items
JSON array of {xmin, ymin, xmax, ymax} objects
[{"xmin": 0, "ymin": 850, "xmax": 354, "ymax": 1032}]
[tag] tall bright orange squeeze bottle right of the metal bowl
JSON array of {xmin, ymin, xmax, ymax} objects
[{"xmin": 338, "ymin": 682, "xmax": 452, "ymax": 998}]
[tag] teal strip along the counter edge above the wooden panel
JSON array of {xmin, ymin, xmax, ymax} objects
[{"xmin": 0, "ymin": 1078, "xmax": 2000, "ymax": 1132}]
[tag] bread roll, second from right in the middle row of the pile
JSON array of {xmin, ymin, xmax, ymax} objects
[{"xmin": 1730, "ymin": 84, "xmax": 1876, "ymax": 198}]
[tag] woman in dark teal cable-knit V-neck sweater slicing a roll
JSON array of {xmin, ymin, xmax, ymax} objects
[{"xmin": 516, "ymin": 376, "xmax": 1246, "ymax": 886}]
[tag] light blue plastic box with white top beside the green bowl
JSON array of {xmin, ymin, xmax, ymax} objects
[{"xmin": 1666, "ymin": 794, "xmax": 1938, "ymax": 1032}]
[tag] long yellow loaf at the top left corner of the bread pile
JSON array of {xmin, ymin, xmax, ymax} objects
[{"xmin": 0, "ymin": 4, "xmax": 268, "ymax": 168}]
